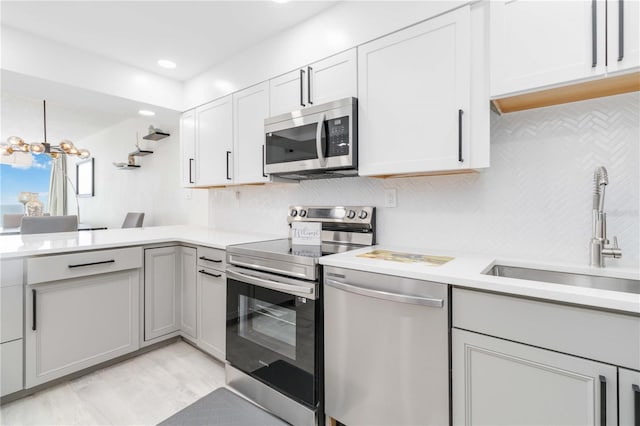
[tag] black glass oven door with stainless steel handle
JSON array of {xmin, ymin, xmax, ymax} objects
[{"xmin": 227, "ymin": 267, "xmax": 320, "ymax": 408}]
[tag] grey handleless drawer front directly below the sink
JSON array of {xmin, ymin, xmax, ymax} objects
[{"xmin": 452, "ymin": 288, "xmax": 640, "ymax": 370}]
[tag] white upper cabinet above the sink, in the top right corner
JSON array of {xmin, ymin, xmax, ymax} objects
[{"xmin": 491, "ymin": 0, "xmax": 640, "ymax": 98}]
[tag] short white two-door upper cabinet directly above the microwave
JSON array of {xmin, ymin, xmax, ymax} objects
[{"xmin": 269, "ymin": 49, "xmax": 358, "ymax": 116}]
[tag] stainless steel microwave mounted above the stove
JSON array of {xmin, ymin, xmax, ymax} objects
[{"xmin": 264, "ymin": 98, "xmax": 358, "ymax": 179}]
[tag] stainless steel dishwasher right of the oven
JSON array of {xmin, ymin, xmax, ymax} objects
[{"xmin": 324, "ymin": 266, "xmax": 450, "ymax": 426}]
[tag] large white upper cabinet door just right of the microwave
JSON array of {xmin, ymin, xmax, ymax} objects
[{"xmin": 358, "ymin": 7, "xmax": 470, "ymax": 176}]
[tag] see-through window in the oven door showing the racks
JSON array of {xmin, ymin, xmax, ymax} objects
[{"xmin": 238, "ymin": 294, "xmax": 296, "ymax": 360}]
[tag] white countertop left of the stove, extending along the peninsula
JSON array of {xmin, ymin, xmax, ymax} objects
[{"xmin": 0, "ymin": 225, "xmax": 286, "ymax": 259}]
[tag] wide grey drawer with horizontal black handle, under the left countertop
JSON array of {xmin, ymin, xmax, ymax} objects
[{"xmin": 27, "ymin": 247, "xmax": 142, "ymax": 284}]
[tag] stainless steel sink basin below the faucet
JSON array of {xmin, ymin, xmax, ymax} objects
[{"xmin": 484, "ymin": 265, "xmax": 640, "ymax": 294}]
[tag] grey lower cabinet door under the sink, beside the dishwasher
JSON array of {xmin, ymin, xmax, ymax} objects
[{"xmin": 452, "ymin": 329, "xmax": 617, "ymax": 426}]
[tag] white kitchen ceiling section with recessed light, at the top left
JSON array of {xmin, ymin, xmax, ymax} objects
[{"xmin": 0, "ymin": 0, "xmax": 336, "ymax": 81}]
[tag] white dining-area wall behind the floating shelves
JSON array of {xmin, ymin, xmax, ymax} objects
[{"xmin": 68, "ymin": 117, "xmax": 208, "ymax": 228}]
